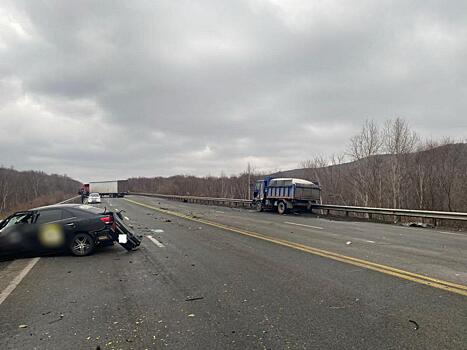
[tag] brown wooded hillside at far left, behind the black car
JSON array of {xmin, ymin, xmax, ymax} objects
[{"xmin": 0, "ymin": 167, "xmax": 80, "ymax": 218}]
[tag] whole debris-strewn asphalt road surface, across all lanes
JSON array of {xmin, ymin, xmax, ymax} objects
[{"xmin": 0, "ymin": 197, "xmax": 467, "ymax": 349}]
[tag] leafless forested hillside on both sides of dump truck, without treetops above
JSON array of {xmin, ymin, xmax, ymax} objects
[{"xmin": 130, "ymin": 143, "xmax": 467, "ymax": 211}]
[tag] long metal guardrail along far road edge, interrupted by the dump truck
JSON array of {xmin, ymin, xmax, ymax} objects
[{"xmin": 130, "ymin": 193, "xmax": 467, "ymax": 225}]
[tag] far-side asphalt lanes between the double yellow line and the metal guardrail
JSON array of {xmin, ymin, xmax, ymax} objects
[{"xmin": 129, "ymin": 197, "xmax": 467, "ymax": 285}]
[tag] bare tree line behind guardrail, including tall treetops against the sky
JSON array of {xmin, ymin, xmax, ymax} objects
[{"xmin": 129, "ymin": 118, "xmax": 467, "ymax": 211}]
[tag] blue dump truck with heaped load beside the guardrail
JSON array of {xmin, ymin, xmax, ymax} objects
[{"xmin": 253, "ymin": 177, "xmax": 321, "ymax": 214}]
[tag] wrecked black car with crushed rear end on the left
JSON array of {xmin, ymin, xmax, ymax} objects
[{"xmin": 0, "ymin": 204, "xmax": 141, "ymax": 259}]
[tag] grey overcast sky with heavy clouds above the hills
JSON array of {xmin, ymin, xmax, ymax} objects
[{"xmin": 0, "ymin": 0, "xmax": 467, "ymax": 181}]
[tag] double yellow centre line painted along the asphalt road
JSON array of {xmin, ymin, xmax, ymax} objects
[{"xmin": 125, "ymin": 198, "xmax": 467, "ymax": 296}]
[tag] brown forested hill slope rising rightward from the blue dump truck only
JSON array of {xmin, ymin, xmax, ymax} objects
[{"xmin": 273, "ymin": 143, "xmax": 467, "ymax": 212}]
